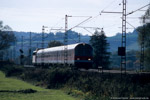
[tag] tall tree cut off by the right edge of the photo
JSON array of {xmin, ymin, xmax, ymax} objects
[{"xmin": 137, "ymin": 6, "xmax": 150, "ymax": 70}]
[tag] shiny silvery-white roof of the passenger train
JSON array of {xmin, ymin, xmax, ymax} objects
[{"xmin": 37, "ymin": 43, "xmax": 86, "ymax": 53}]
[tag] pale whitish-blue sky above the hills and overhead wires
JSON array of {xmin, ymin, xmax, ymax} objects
[{"xmin": 0, "ymin": 0, "xmax": 150, "ymax": 36}]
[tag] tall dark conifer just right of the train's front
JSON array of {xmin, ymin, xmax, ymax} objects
[{"xmin": 90, "ymin": 30, "xmax": 110, "ymax": 69}]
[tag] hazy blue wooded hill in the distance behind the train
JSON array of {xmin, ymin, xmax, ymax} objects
[{"xmin": 10, "ymin": 30, "xmax": 139, "ymax": 55}]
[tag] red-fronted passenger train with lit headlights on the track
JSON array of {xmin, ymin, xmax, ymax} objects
[{"xmin": 32, "ymin": 43, "xmax": 93, "ymax": 69}]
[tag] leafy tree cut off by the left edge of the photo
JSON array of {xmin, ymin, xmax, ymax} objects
[{"xmin": 0, "ymin": 21, "xmax": 16, "ymax": 51}]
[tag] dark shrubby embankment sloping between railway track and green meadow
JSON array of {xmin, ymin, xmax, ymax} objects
[{"xmin": 0, "ymin": 65, "xmax": 150, "ymax": 100}]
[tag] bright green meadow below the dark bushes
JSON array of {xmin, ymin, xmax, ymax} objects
[{"xmin": 0, "ymin": 71, "xmax": 77, "ymax": 100}]
